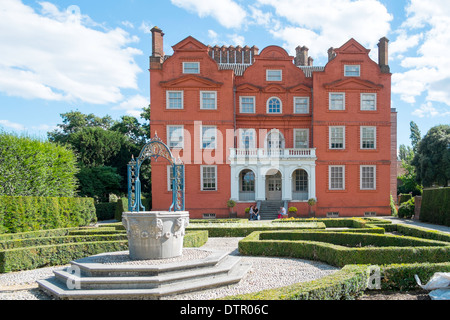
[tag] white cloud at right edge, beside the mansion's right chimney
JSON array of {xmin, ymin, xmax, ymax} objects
[{"xmin": 392, "ymin": 0, "xmax": 450, "ymax": 107}]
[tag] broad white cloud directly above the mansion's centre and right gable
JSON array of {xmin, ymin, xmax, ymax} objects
[{"xmin": 258, "ymin": 0, "xmax": 392, "ymax": 58}]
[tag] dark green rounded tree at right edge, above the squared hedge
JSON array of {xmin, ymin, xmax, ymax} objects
[{"xmin": 412, "ymin": 125, "xmax": 450, "ymax": 187}]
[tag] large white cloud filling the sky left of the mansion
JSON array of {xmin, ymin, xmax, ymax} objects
[{"xmin": 0, "ymin": 0, "xmax": 142, "ymax": 104}]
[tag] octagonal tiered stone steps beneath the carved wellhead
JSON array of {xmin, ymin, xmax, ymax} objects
[{"xmin": 38, "ymin": 252, "xmax": 251, "ymax": 300}]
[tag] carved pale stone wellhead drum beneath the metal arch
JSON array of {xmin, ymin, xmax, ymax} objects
[{"xmin": 122, "ymin": 211, "xmax": 189, "ymax": 260}]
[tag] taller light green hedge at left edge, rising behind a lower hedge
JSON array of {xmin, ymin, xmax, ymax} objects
[{"xmin": 0, "ymin": 131, "xmax": 78, "ymax": 197}]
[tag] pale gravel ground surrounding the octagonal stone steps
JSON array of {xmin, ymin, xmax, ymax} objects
[{"xmin": 0, "ymin": 238, "xmax": 339, "ymax": 300}]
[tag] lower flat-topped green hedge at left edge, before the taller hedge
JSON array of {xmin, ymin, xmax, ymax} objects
[{"xmin": 0, "ymin": 196, "xmax": 97, "ymax": 233}]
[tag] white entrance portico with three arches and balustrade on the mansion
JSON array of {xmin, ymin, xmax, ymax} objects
[{"xmin": 230, "ymin": 149, "xmax": 316, "ymax": 202}]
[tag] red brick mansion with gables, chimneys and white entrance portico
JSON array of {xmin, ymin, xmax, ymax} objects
[{"xmin": 150, "ymin": 28, "xmax": 396, "ymax": 218}]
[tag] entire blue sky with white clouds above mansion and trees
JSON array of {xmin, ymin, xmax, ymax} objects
[{"xmin": 0, "ymin": 0, "xmax": 450, "ymax": 149}]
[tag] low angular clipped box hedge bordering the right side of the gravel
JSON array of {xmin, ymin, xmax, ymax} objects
[{"xmin": 239, "ymin": 231, "xmax": 450, "ymax": 267}]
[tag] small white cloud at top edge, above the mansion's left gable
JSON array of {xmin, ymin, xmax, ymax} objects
[{"xmin": 171, "ymin": 0, "xmax": 247, "ymax": 28}]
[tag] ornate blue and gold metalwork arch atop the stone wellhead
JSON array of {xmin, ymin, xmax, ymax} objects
[{"xmin": 128, "ymin": 133, "xmax": 185, "ymax": 212}]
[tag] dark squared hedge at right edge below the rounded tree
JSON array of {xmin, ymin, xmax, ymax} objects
[{"xmin": 420, "ymin": 188, "xmax": 450, "ymax": 227}]
